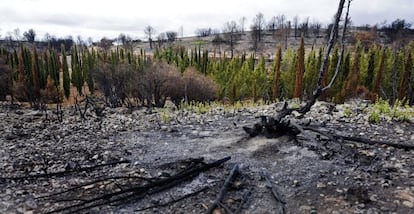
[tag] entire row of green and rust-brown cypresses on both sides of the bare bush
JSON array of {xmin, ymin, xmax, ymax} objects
[{"xmin": 0, "ymin": 38, "xmax": 414, "ymax": 104}]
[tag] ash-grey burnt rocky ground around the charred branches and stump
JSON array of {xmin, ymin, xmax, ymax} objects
[{"xmin": 0, "ymin": 102, "xmax": 414, "ymax": 213}]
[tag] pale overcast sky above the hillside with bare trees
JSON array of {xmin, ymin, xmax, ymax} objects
[{"xmin": 0, "ymin": 0, "xmax": 414, "ymax": 40}]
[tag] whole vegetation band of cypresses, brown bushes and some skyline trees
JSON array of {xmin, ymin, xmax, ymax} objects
[{"xmin": 0, "ymin": 18, "xmax": 414, "ymax": 110}]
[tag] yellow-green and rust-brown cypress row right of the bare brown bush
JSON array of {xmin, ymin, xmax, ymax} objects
[{"xmin": 156, "ymin": 38, "xmax": 414, "ymax": 105}]
